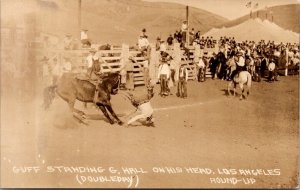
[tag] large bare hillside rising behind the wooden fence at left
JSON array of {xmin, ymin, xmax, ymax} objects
[{"xmin": 2, "ymin": 0, "xmax": 228, "ymax": 44}]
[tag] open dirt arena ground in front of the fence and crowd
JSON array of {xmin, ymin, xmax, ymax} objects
[{"xmin": 1, "ymin": 76, "xmax": 299, "ymax": 188}]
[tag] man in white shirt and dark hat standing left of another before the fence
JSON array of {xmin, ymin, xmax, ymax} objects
[{"xmin": 157, "ymin": 57, "xmax": 171, "ymax": 97}]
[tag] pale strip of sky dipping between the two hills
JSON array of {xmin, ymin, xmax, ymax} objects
[{"xmin": 144, "ymin": 0, "xmax": 300, "ymax": 20}]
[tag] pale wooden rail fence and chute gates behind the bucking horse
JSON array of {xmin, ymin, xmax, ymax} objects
[{"xmin": 45, "ymin": 44, "xmax": 216, "ymax": 86}]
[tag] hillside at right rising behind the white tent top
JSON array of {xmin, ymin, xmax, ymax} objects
[{"xmin": 218, "ymin": 4, "xmax": 300, "ymax": 33}]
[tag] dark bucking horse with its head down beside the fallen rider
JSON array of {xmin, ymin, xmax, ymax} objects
[{"xmin": 44, "ymin": 73, "xmax": 123, "ymax": 125}]
